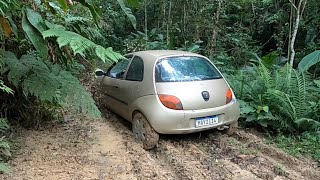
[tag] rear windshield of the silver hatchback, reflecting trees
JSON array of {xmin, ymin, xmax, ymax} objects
[{"xmin": 155, "ymin": 56, "xmax": 222, "ymax": 82}]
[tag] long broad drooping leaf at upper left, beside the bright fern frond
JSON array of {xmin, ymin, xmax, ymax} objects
[{"xmin": 22, "ymin": 13, "xmax": 48, "ymax": 58}]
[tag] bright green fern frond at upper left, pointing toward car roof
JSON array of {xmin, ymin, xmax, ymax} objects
[{"xmin": 42, "ymin": 22, "xmax": 122, "ymax": 62}]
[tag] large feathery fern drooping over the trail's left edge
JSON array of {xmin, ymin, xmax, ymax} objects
[{"xmin": 0, "ymin": 50, "xmax": 100, "ymax": 117}]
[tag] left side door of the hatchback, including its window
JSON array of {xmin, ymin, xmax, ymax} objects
[{"xmin": 102, "ymin": 56, "xmax": 132, "ymax": 118}]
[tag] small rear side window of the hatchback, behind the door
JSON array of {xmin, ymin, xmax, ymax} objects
[{"xmin": 126, "ymin": 56, "xmax": 144, "ymax": 81}]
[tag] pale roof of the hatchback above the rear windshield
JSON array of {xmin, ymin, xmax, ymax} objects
[{"xmin": 130, "ymin": 50, "xmax": 201, "ymax": 59}]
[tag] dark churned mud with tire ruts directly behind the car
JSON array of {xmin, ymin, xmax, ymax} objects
[{"xmin": 99, "ymin": 107, "xmax": 320, "ymax": 180}]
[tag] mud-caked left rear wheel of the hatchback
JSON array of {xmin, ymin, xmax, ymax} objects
[{"xmin": 132, "ymin": 113, "xmax": 159, "ymax": 150}]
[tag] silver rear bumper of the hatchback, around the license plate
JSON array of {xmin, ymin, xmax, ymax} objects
[{"xmin": 131, "ymin": 96, "xmax": 240, "ymax": 134}]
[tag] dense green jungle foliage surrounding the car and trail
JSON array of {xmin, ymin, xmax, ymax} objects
[{"xmin": 0, "ymin": 0, "xmax": 320, "ymax": 172}]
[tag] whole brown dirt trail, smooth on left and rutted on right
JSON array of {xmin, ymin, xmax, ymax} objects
[{"xmin": 0, "ymin": 109, "xmax": 320, "ymax": 180}]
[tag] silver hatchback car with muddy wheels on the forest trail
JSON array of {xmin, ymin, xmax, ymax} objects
[{"xmin": 96, "ymin": 50, "xmax": 240, "ymax": 149}]
